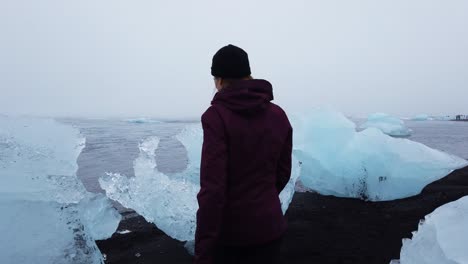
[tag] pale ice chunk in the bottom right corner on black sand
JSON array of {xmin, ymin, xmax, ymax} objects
[{"xmin": 399, "ymin": 196, "xmax": 468, "ymax": 264}]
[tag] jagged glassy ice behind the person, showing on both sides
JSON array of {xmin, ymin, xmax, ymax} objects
[{"xmin": 99, "ymin": 124, "xmax": 300, "ymax": 241}]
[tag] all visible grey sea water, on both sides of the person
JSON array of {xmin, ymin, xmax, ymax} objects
[{"xmin": 59, "ymin": 119, "xmax": 468, "ymax": 197}]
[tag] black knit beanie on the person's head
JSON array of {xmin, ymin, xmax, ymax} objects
[{"xmin": 211, "ymin": 45, "xmax": 251, "ymax": 79}]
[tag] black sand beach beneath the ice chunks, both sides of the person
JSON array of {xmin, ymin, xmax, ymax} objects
[{"xmin": 97, "ymin": 167, "xmax": 468, "ymax": 264}]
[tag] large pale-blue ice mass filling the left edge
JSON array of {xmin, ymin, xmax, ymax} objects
[{"xmin": 0, "ymin": 116, "xmax": 121, "ymax": 264}]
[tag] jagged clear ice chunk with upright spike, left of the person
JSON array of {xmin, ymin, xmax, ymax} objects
[{"xmin": 99, "ymin": 137, "xmax": 200, "ymax": 241}]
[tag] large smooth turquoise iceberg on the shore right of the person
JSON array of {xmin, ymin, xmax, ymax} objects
[{"xmin": 293, "ymin": 110, "xmax": 468, "ymax": 201}]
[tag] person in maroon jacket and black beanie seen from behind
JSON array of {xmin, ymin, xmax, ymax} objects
[{"xmin": 194, "ymin": 45, "xmax": 292, "ymax": 264}]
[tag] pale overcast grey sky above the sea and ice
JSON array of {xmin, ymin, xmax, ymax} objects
[{"xmin": 0, "ymin": 0, "xmax": 468, "ymax": 118}]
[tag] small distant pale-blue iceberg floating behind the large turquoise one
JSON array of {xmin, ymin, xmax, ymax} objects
[{"xmin": 360, "ymin": 113, "xmax": 412, "ymax": 137}]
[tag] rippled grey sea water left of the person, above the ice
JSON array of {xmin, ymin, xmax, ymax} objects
[{"xmin": 59, "ymin": 119, "xmax": 189, "ymax": 192}]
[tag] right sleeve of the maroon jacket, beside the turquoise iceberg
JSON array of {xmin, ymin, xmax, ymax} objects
[{"xmin": 276, "ymin": 126, "xmax": 293, "ymax": 193}]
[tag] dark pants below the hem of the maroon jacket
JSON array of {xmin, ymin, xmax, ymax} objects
[{"xmin": 215, "ymin": 238, "xmax": 282, "ymax": 264}]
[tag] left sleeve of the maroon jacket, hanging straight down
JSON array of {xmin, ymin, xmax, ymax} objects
[{"xmin": 195, "ymin": 107, "xmax": 227, "ymax": 264}]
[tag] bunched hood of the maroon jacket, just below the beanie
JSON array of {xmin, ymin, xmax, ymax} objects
[{"xmin": 211, "ymin": 80, "xmax": 273, "ymax": 114}]
